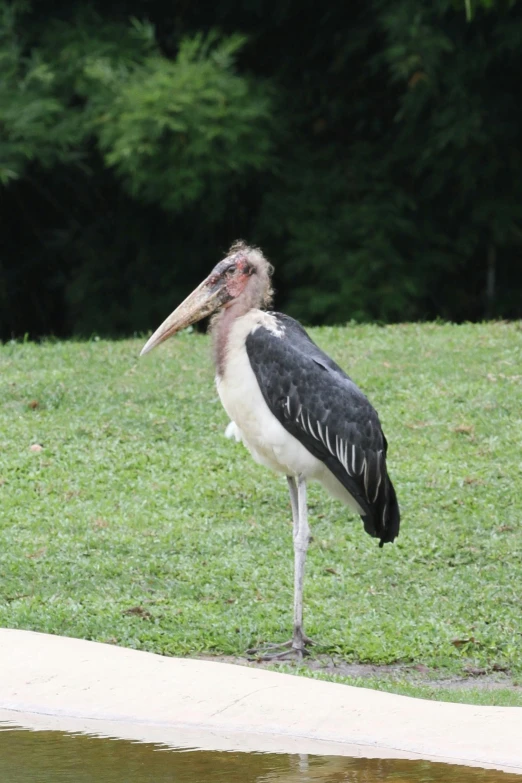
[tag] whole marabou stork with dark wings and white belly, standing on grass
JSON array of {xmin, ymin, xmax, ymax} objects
[{"xmin": 140, "ymin": 240, "xmax": 400, "ymax": 660}]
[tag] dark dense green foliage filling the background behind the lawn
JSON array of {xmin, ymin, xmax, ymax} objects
[{"xmin": 0, "ymin": 0, "xmax": 522, "ymax": 337}]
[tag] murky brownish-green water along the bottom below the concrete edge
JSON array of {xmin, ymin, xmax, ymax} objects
[{"xmin": 0, "ymin": 727, "xmax": 521, "ymax": 783}]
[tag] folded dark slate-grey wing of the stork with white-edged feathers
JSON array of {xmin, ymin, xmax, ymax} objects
[{"xmin": 246, "ymin": 313, "xmax": 400, "ymax": 546}]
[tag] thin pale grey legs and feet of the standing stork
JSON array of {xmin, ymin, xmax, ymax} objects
[{"xmin": 247, "ymin": 475, "xmax": 313, "ymax": 661}]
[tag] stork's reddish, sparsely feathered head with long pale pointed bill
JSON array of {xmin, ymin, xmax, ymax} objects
[{"xmin": 140, "ymin": 242, "xmax": 273, "ymax": 356}]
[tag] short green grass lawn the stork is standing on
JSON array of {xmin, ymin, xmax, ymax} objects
[{"xmin": 0, "ymin": 323, "xmax": 522, "ymax": 704}]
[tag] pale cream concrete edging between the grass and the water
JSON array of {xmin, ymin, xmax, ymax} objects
[{"xmin": 0, "ymin": 629, "xmax": 522, "ymax": 775}]
